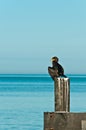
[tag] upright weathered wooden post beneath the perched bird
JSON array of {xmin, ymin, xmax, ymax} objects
[{"xmin": 54, "ymin": 78, "xmax": 70, "ymax": 112}]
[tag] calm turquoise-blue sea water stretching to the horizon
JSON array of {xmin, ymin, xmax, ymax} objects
[{"xmin": 0, "ymin": 74, "xmax": 86, "ymax": 130}]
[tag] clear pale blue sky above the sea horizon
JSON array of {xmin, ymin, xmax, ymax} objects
[{"xmin": 0, "ymin": 0, "xmax": 86, "ymax": 73}]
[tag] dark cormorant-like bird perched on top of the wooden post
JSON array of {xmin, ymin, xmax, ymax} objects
[{"xmin": 48, "ymin": 56, "xmax": 66, "ymax": 80}]
